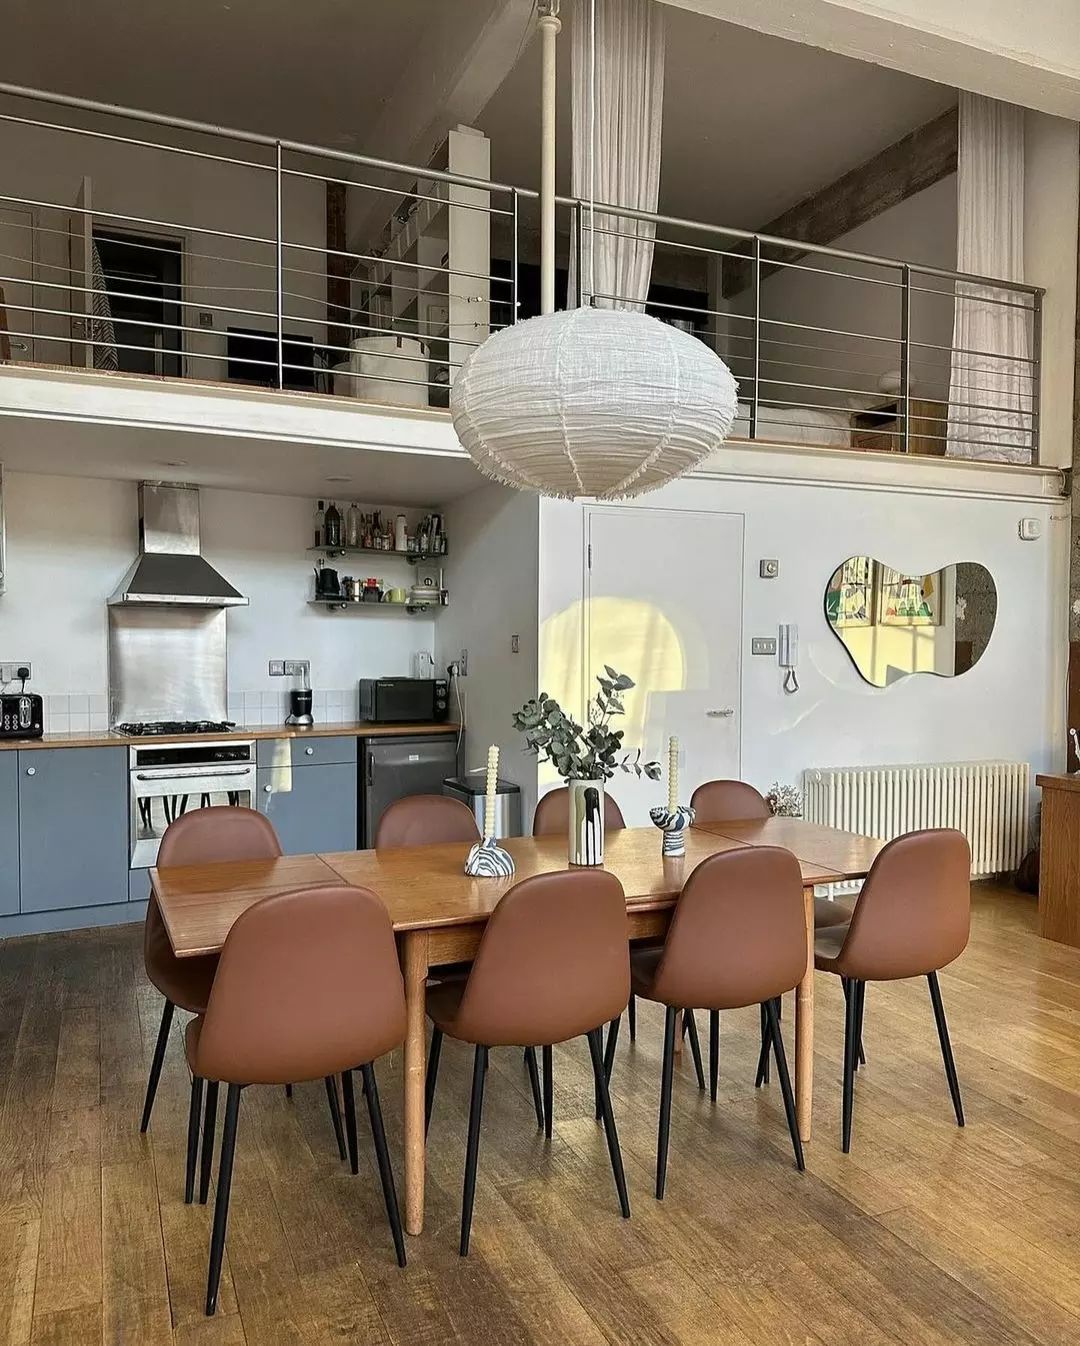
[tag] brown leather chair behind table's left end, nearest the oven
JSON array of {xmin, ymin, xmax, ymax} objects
[{"xmin": 139, "ymin": 808, "xmax": 281, "ymax": 1131}]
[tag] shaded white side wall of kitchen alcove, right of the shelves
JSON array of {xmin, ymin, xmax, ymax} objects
[{"xmin": 435, "ymin": 486, "xmax": 538, "ymax": 829}]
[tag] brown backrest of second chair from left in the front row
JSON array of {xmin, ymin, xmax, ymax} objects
[{"xmin": 455, "ymin": 870, "xmax": 630, "ymax": 1047}]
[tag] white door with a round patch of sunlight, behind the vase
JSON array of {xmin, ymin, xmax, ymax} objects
[{"xmin": 584, "ymin": 506, "xmax": 743, "ymax": 826}]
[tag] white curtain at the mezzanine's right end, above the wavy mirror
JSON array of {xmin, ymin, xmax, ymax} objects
[{"xmin": 947, "ymin": 93, "xmax": 1032, "ymax": 463}]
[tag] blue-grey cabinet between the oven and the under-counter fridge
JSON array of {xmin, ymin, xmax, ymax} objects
[{"xmin": 256, "ymin": 738, "xmax": 357, "ymax": 855}]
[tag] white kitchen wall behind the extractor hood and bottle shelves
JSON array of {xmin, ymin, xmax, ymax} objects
[{"xmin": 0, "ymin": 472, "xmax": 442, "ymax": 728}]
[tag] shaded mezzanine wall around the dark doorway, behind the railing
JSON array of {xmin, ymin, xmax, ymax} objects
[{"xmin": 0, "ymin": 110, "xmax": 326, "ymax": 378}]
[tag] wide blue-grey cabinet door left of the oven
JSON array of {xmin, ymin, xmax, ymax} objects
[{"xmin": 17, "ymin": 747, "xmax": 128, "ymax": 911}]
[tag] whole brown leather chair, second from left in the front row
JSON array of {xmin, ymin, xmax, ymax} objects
[{"xmin": 427, "ymin": 870, "xmax": 630, "ymax": 1256}]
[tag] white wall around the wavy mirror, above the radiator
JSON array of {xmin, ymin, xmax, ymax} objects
[{"xmin": 539, "ymin": 479, "xmax": 1068, "ymax": 787}]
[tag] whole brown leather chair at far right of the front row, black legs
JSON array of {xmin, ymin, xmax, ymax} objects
[{"xmin": 813, "ymin": 828, "xmax": 971, "ymax": 1154}]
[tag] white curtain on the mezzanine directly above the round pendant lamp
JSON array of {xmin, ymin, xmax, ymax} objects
[{"xmin": 570, "ymin": 0, "xmax": 664, "ymax": 310}]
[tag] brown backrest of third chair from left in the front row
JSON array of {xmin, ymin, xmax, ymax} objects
[{"xmin": 643, "ymin": 847, "xmax": 807, "ymax": 1010}]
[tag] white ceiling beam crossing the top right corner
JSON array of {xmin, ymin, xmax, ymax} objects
[{"xmin": 651, "ymin": 0, "xmax": 1080, "ymax": 120}]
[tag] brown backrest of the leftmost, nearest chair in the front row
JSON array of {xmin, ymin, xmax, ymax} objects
[{"xmin": 193, "ymin": 887, "xmax": 405, "ymax": 1084}]
